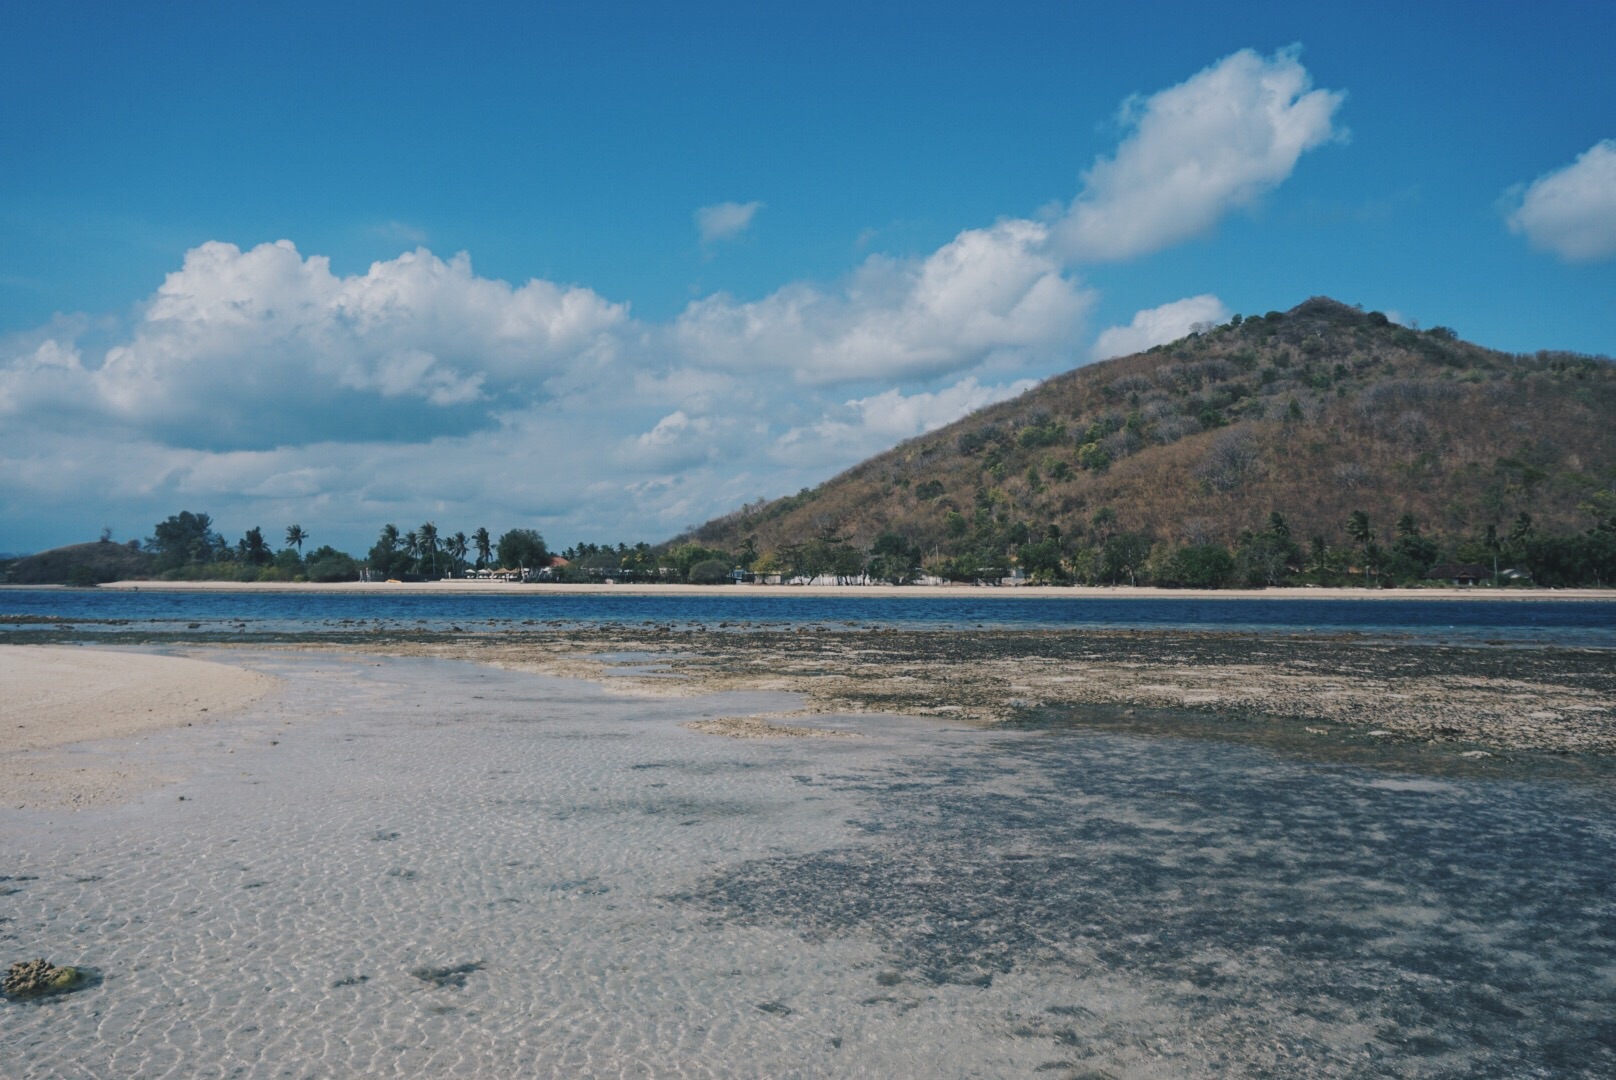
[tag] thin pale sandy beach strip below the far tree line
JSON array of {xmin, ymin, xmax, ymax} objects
[{"xmin": 9, "ymin": 580, "xmax": 1616, "ymax": 601}]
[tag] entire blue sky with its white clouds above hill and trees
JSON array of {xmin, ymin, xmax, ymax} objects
[{"xmin": 0, "ymin": 3, "xmax": 1616, "ymax": 550}]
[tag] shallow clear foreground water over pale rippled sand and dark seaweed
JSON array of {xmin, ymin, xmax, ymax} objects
[{"xmin": 0, "ymin": 653, "xmax": 1616, "ymax": 1077}]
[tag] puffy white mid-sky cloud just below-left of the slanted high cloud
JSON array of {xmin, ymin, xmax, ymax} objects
[{"xmin": 672, "ymin": 220, "xmax": 1092, "ymax": 385}]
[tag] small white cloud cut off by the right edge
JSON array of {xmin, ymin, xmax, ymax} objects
[{"xmin": 1508, "ymin": 139, "xmax": 1616, "ymax": 262}]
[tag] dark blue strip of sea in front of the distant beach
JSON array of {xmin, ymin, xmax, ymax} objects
[{"xmin": 0, "ymin": 587, "xmax": 1616, "ymax": 648}]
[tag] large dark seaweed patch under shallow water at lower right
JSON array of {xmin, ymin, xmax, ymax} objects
[{"xmin": 672, "ymin": 730, "xmax": 1616, "ymax": 1075}]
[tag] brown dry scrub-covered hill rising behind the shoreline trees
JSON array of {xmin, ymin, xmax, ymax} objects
[{"xmin": 680, "ymin": 297, "xmax": 1616, "ymax": 584}]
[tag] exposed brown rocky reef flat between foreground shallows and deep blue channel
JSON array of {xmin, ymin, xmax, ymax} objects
[{"xmin": 347, "ymin": 626, "xmax": 1616, "ymax": 755}]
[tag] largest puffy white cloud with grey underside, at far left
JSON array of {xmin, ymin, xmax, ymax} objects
[{"xmin": 0, "ymin": 241, "xmax": 627, "ymax": 448}]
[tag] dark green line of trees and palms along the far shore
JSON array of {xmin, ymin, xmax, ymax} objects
[{"xmin": 0, "ymin": 508, "xmax": 1616, "ymax": 589}]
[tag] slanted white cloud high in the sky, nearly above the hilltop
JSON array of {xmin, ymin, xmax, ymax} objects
[{"xmin": 1057, "ymin": 47, "xmax": 1345, "ymax": 260}]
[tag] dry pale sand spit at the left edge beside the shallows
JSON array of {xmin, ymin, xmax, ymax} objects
[{"xmin": 0, "ymin": 645, "xmax": 276, "ymax": 808}]
